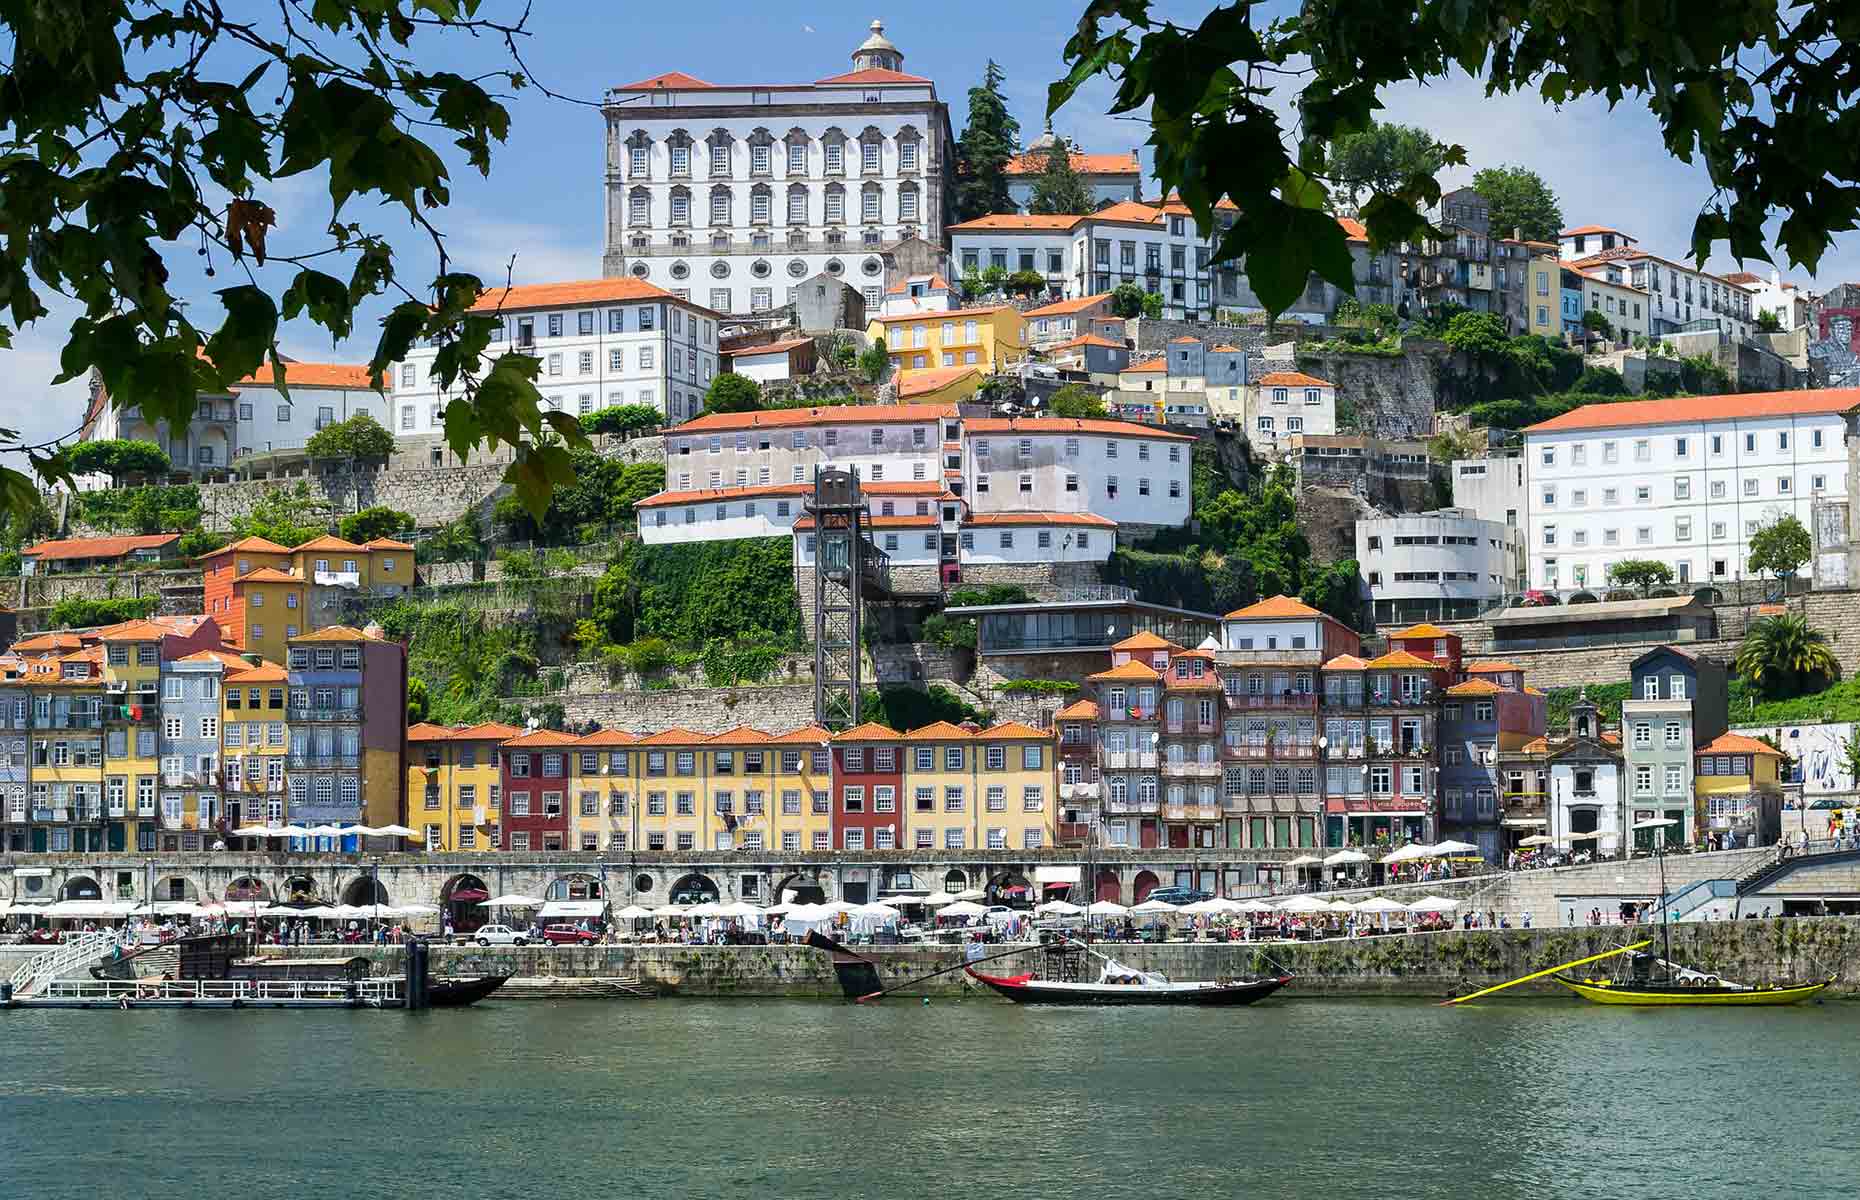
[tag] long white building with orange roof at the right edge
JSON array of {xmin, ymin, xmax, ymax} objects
[{"xmin": 1523, "ymin": 389, "xmax": 1860, "ymax": 590}]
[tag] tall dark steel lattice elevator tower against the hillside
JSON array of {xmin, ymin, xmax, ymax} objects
[{"xmin": 807, "ymin": 467, "xmax": 889, "ymax": 729}]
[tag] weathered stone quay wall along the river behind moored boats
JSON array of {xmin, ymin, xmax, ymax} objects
[{"xmin": 268, "ymin": 917, "xmax": 1860, "ymax": 999}]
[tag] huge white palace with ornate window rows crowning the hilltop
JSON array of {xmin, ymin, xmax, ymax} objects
[{"xmin": 603, "ymin": 20, "xmax": 956, "ymax": 313}]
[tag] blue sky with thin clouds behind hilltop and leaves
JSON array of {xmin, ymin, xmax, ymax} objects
[{"xmin": 0, "ymin": 0, "xmax": 1860, "ymax": 453}]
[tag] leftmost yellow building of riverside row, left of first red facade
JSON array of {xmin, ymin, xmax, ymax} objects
[{"xmin": 407, "ymin": 722, "xmax": 523, "ymax": 854}]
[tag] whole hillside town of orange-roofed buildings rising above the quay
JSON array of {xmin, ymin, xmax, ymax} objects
[{"xmin": 0, "ymin": 22, "xmax": 1860, "ymax": 937}]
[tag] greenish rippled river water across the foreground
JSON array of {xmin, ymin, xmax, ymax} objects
[{"xmin": 0, "ymin": 997, "xmax": 1860, "ymax": 1200}]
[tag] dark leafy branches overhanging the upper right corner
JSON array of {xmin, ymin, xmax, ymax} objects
[{"xmin": 1047, "ymin": 0, "xmax": 1860, "ymax": 313}]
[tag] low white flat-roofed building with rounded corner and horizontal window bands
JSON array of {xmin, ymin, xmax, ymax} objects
[{"xmin": 1356, "ymin": 508, "xmax": 1523, "ymax": 625}]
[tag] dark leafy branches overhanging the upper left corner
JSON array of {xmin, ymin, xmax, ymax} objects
[{"xmin": 0, "ymin": 0, "xmax": 578, "ymax": 520}]
